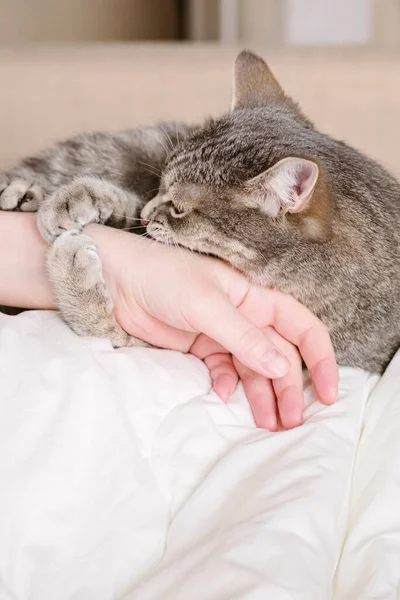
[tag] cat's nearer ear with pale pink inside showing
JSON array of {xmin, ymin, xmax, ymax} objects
[{"xmin": 246, "ymin": 157, "xmax": 319, "ymax": 217}]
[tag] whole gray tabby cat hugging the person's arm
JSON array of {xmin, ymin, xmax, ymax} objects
[{"xmin": 0, "ymin": 51, "xmax": 400, "ymax": 371}]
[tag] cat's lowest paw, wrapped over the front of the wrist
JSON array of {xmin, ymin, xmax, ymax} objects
[{"xmin": 47, "ymin": 230, "xmax": 148, "ymax": 348}]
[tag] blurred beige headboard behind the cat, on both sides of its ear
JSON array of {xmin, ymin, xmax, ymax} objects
[{"xmin": 0, "ymin": 44, "xmax": 400, "ymax": 175}]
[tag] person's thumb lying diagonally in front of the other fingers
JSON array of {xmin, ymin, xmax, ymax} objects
[{"xmin": 187, "ymin": 293, "xmax": 290, "ymax": 379}]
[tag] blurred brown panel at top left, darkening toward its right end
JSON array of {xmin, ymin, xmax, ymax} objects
[{"xmin": 0, "ymin": 0, "xmax": 178, "ymax": 46}]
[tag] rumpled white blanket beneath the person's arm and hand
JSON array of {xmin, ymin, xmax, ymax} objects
[{"xmin": 0, "ymin": 312, "xmax": 400, "ymax": 600}]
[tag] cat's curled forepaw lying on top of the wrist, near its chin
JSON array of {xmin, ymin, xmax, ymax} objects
[{"xmin": 38, "ymin": 177, "xmax": 114, "ymax": 243}]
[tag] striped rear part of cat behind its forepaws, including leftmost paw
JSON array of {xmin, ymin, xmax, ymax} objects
[{"xmin": 0, "ymin": 123, "xmax": 190, "ymax": 220}]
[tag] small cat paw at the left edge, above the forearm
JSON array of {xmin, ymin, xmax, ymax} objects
[{"xmin": 0, "ymin": 175, "xmax": 43, "ymax": 212}]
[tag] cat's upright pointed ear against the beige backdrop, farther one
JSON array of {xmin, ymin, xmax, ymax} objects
[{"xmin": 231, "ymin": 50, "xmax": 286, "ymax": 110}]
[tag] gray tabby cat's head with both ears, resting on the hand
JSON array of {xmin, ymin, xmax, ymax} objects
[{"xmin": 142, "ymin": 51, "xmax": 332, "ymax": 271}]
